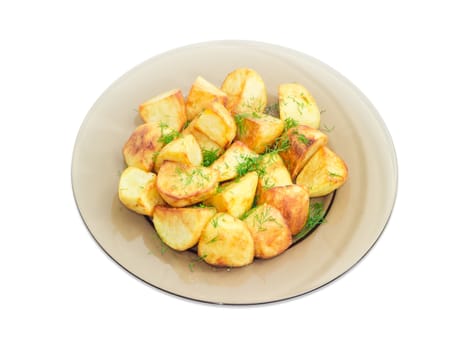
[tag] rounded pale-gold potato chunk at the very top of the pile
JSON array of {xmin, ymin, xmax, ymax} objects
[{"xmin": 221, "ymin": 68, "xmax": 267, "ymax": 115}]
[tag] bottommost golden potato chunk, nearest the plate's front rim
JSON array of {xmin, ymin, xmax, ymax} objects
[{"xmin": 197, "ymin": 213, "xmax": 254, "ymax": 267}]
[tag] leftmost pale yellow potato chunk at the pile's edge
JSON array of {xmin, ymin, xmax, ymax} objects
[{"xmin": 119, "ymin": 167, "xmax": 165, "ymax": 216}]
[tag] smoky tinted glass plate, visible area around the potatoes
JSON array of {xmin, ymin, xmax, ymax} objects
[{"xmin": 72, "ymin": 41, "xmax": 397, "ymax": 304}]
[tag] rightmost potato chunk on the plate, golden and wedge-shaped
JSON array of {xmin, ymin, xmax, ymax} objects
[{"xmin": 296, "ymin": 146, "xmax": 348, "ymax": 197}]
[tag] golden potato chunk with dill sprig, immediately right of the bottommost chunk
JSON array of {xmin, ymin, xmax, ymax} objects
[{"xmin": 243, "ymin": 204, "xmax": 292, "ymax": 259}]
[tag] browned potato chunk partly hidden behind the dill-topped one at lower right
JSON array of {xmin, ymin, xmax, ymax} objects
[{"xmin": 258, "ymin": 185, "xmax": 310, "ymax": 235}]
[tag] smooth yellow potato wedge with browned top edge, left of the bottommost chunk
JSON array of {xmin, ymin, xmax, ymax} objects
[{"xmin": 152, "ymin": 206, "xmax": 216, "ymax": 251}]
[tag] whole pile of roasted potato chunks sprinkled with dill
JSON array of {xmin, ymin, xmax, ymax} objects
[{"xmin": 118, "ymin": 67, "xmax": 348, "ymax": 268}]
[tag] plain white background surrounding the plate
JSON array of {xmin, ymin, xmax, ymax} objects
[{"xmin": 0, "ymin": 0, "xmax": 462, "ymax": 349}]
